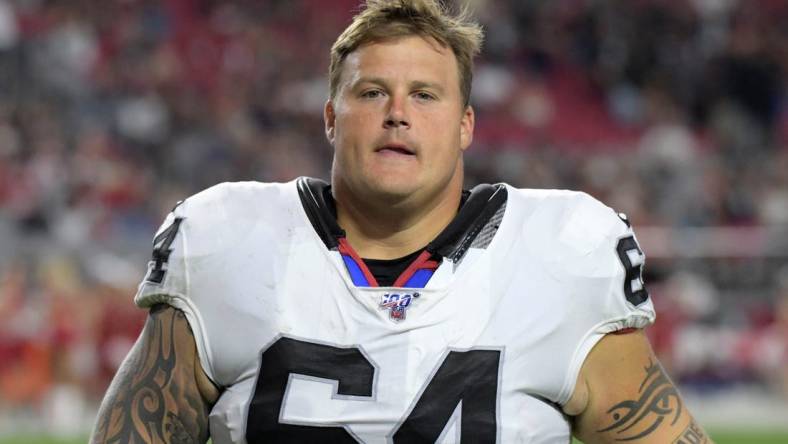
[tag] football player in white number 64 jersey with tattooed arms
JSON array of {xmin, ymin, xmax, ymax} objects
[{"xmin": 92, "ymin": 0, "xmax": 708, "ymax": 444}]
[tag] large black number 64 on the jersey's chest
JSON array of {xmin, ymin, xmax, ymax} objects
[{"xmin": 246, "ymin": 337, "xmax": 501, "ymax": 444}]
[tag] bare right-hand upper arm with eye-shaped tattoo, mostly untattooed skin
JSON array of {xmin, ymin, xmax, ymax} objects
[{"xmin": 565, "ymin": 330, "xmax": 711, "ymax": 444}]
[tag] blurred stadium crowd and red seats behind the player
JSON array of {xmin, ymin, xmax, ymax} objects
[{"xmin": 0, "ymin": 0, "xmax": 788, "ymax": 443}]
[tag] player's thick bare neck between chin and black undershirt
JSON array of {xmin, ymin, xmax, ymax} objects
[{"xmin": 333, "ymin": 178, "xmax": 462, "ymax": 259}]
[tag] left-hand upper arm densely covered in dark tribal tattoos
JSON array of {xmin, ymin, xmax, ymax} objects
[{"xmin": 90, "ymin": 305, "xmax": 218, "ymax": 444}]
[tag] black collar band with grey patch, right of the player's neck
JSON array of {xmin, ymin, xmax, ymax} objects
[{"xmin": 427, "ymin": 184, "xmax": 508, "ymax": 262}]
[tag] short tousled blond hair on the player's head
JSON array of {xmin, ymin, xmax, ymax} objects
[{"xmin": 328, "ymin": 0, "xmax": 484, "ymax": 106}]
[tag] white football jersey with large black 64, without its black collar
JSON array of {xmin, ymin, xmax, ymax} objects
[{"xmin": 135, "ymin": 179, "xmax": 654, "ymax": 444}]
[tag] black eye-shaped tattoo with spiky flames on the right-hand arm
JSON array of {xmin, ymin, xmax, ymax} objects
[{"xmin": 598, "ymin": 363, "xmax": 682, "ymax": 441}]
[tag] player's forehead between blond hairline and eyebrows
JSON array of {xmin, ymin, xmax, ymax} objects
[{"xmin": 342, "ymin": 36, "xmax": 459, "ymax": 87}]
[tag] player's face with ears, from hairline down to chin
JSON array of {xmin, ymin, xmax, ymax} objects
[{"xmin": 325, "ymin": 36, "xmax": 474, "ymax": 203}]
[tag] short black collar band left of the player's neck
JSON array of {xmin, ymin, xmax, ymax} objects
[{"xmin": 297, "ymin": 177, "xmax": 345, "ymax": 250}]
